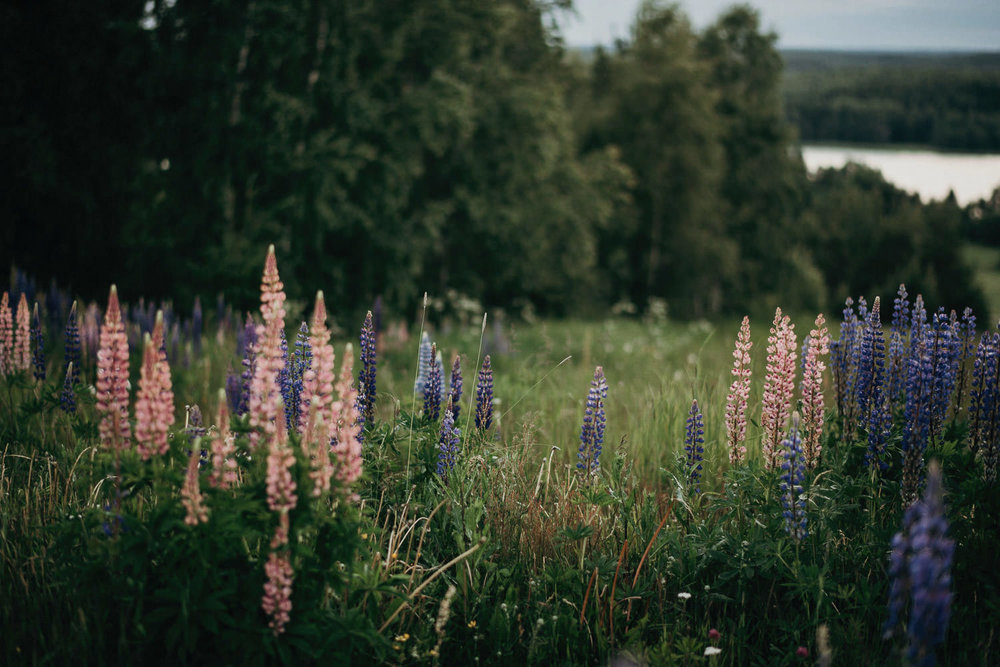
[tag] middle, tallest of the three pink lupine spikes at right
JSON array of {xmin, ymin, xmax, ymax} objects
[{"xmin": 760, "ymin": 308, "xmax": 796, "ymax": 469}]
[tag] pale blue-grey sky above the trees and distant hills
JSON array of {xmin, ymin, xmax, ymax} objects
[{"xmin": 561, "ymin": 0, "xmax": 1000, "ymax": 51}]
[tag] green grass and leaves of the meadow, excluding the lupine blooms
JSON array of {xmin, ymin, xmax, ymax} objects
[{"xmin": 0, "ymin": 264, "xmax": 1000, "ymax": 665}]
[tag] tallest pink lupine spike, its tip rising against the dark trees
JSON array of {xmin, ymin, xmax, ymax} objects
[{"xmin": 249, "ymin": 245, "xmax": 285, "ymax": 446}]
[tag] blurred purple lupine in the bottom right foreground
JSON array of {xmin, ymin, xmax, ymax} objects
[{"xmin": 885, "ymin": 461, "xmax": 955, "ymax": 665}]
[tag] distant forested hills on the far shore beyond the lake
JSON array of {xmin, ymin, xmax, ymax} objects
[{"xmin": 784, "ymin": 51, "xmax": 1000, "ymax": 151}]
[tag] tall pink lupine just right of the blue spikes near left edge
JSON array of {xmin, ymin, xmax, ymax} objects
[{"xmin": 97, "ymin": 285, "xmax": 131, "ymax": 449}]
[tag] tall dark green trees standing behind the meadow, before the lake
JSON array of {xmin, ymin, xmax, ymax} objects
[{"xmin": 0, "ymin": 0, "xmax": 979, "ymax": 316}]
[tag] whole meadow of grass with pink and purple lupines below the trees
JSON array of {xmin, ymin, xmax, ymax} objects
[{"xmin": 0, "ymin": 250, "xmax": 1000, "ymax": 665}]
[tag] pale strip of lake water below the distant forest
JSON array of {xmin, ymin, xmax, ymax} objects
[{"xmin": 802, "ymin": 144, "xmax": 1000, "ymax": 206}]
